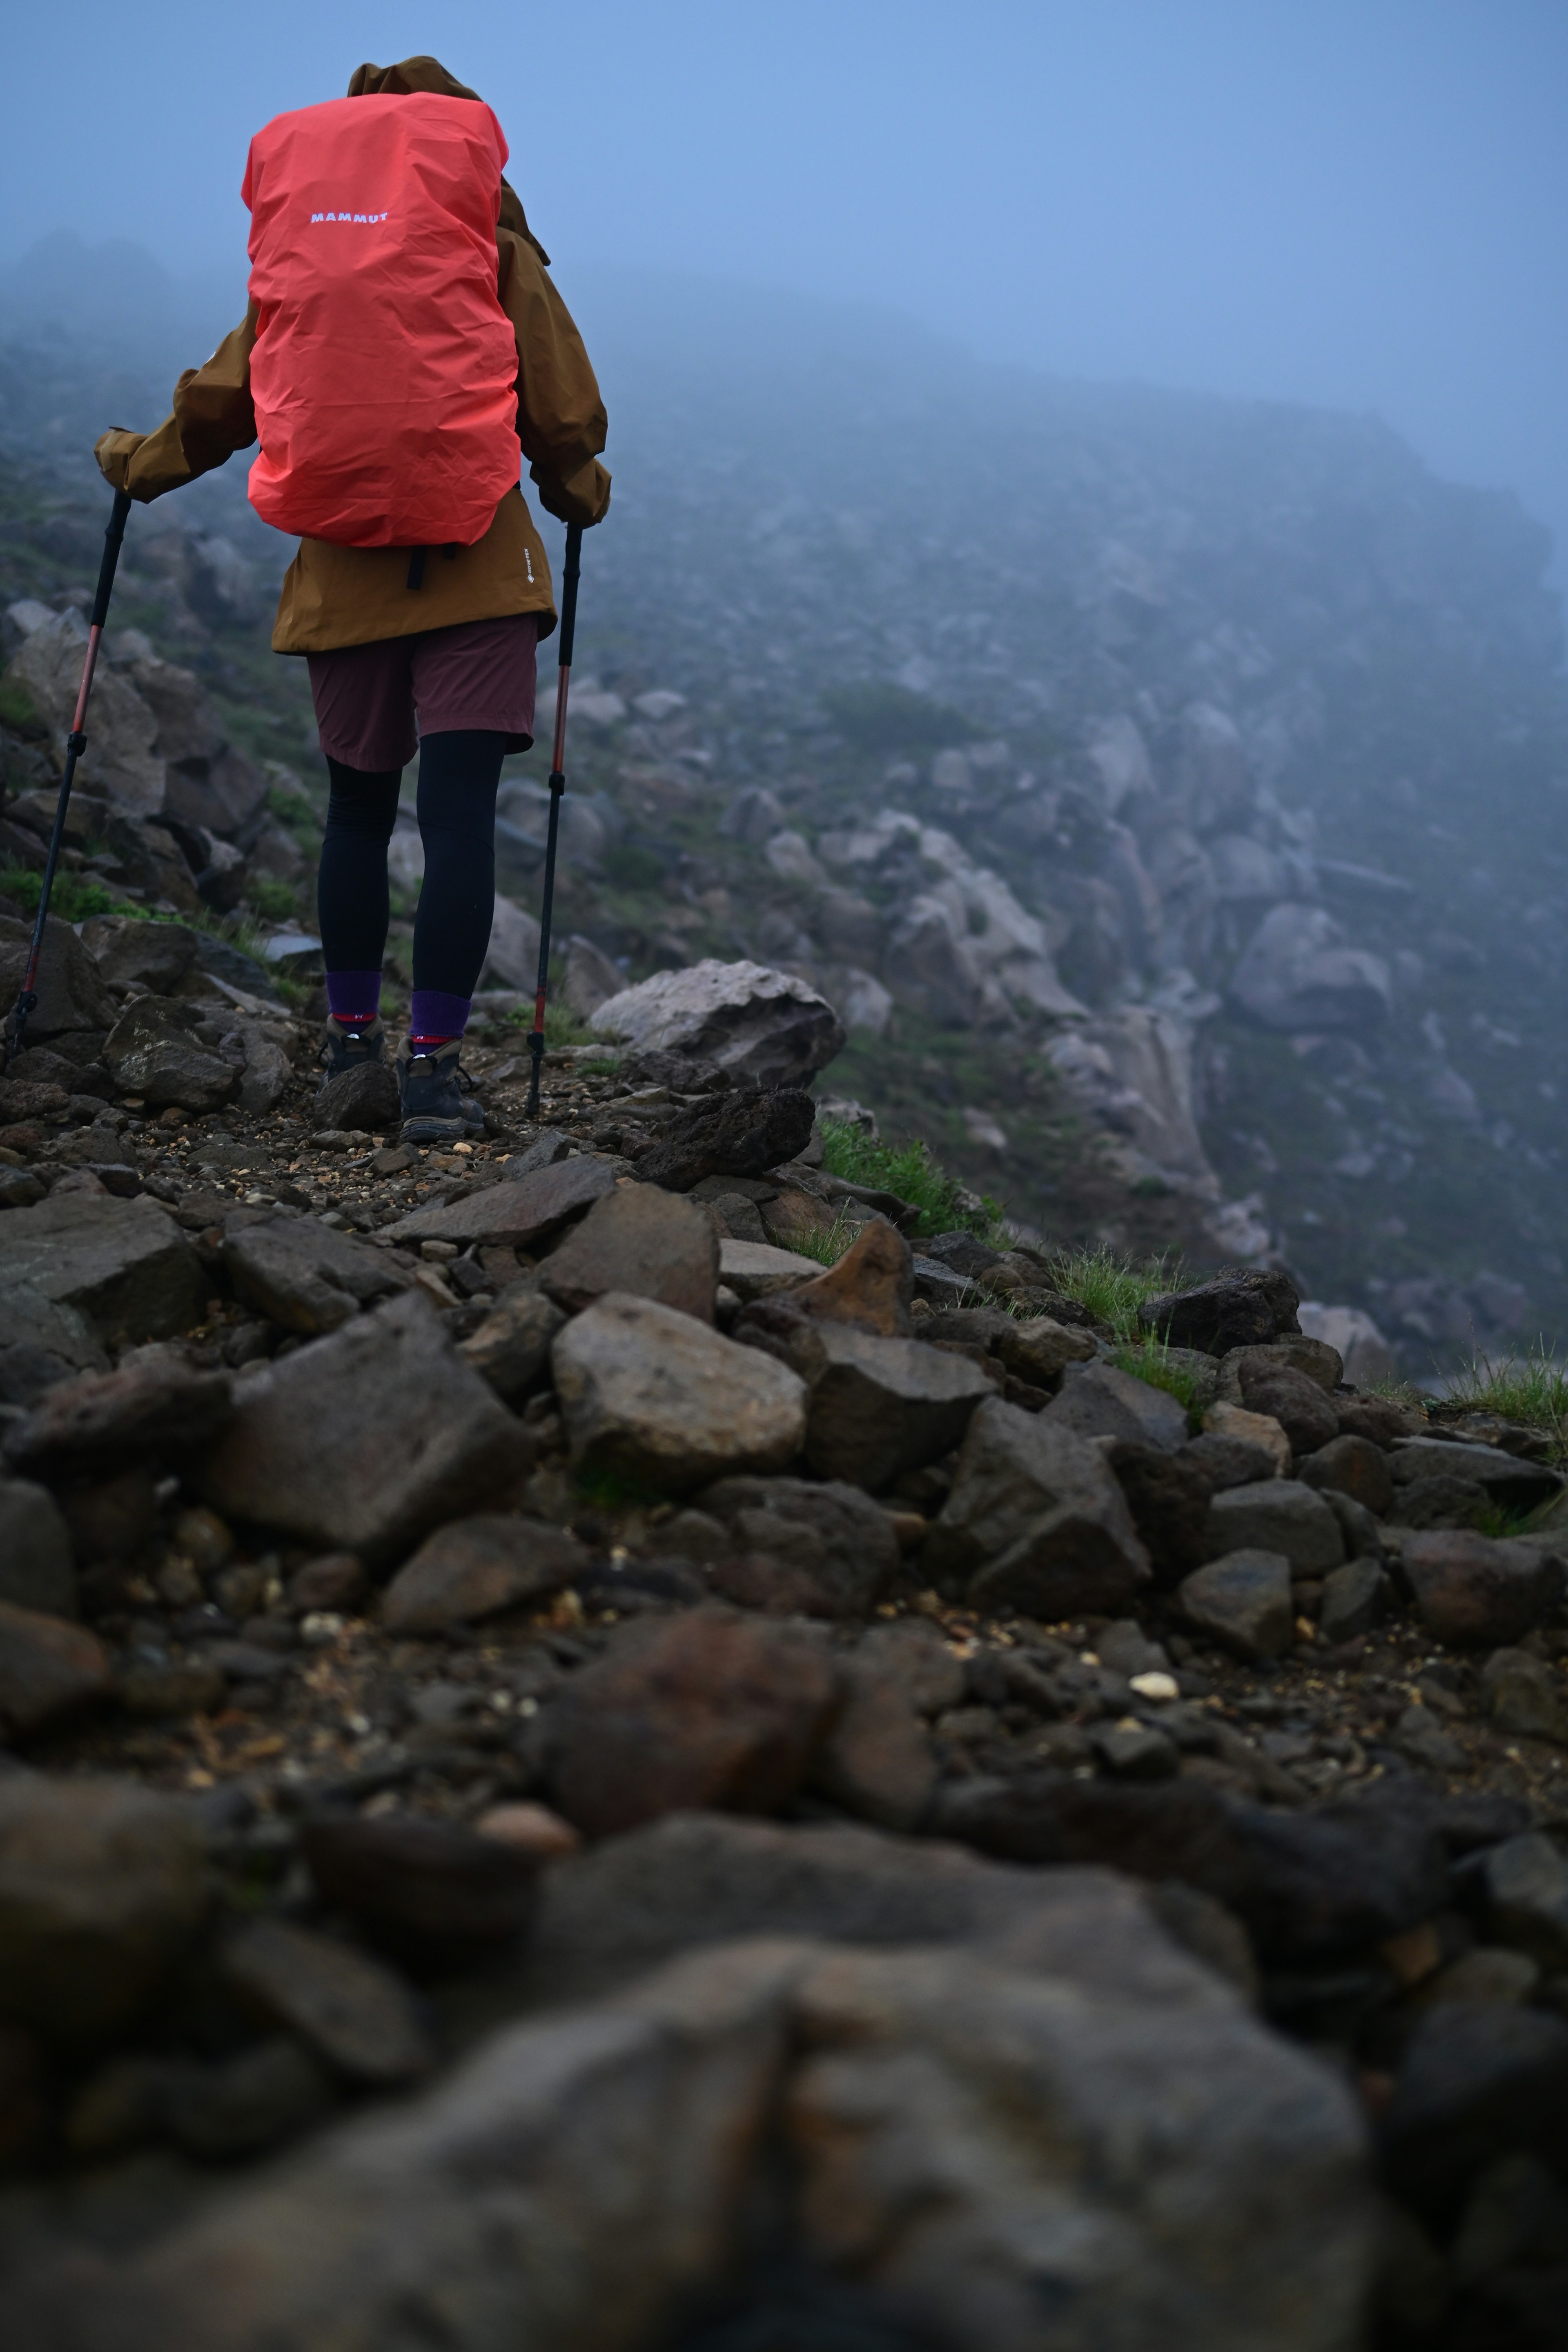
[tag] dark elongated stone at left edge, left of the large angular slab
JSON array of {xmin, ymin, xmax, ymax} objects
[{"xmin": 5, "ymin": 1357, "xmax": 233, "ymax": 1484}]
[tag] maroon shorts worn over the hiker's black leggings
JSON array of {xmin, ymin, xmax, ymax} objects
[{"xmin": 308, "ymin": 612, "xmax": 538, "ymax": 774}]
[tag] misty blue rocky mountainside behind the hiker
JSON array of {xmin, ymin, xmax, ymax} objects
[{"xmin": 0, "ymin": 247, "xmax": 1568, "ymax": 1378}]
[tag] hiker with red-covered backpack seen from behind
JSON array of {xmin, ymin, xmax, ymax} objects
[{"xmin": 96, "ymin": 56, "xmax": 609, "ymax": 1143}]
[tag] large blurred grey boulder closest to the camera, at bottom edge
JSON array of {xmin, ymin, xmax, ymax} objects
[{"xmin": 7, "ymin": 1900, "xmax": 1375, "ymax": 2352}]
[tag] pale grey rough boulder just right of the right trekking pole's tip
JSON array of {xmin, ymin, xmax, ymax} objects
[{"xmin": 590, "ymin": 957, "xmax": 844, "ymax": 1087}]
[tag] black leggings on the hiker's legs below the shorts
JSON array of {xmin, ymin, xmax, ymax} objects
[{"xmin": 315, "ymin": 727, "xmax": 506, "ymax": 997}]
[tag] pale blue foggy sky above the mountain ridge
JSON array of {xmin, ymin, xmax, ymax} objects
[{"xmin": 0, "ymin": 0, "xmax": 1568, "ymax": 581}]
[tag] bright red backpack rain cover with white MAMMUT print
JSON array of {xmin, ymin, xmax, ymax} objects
[{"xmin": 240, "ymin": 92, "xmax": 519, "ymax": 548}]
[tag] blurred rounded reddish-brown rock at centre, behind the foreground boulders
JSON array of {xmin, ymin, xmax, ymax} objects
[{"xmin": 546, "ymin": 1609, "xmax": 839, "ymax": 1837}]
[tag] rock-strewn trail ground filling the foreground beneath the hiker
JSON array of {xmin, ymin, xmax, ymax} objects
[{"xmin": 0, "ymin": 917, "xmax": 1568, "ymax": 2352}]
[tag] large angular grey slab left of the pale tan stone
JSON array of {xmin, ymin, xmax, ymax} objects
[{"xmin": 195, "ymin": 1291, "xmax": 531, "ymax": 1562}]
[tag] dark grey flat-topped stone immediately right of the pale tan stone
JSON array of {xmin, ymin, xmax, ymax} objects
[{"xmin": 780, "ymin": 1326, "xmax": 997, "ymax": 1494}]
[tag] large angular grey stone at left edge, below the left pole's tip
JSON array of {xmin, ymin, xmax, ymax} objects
[{"xmin": 0, "ymin": 1195, "xmax": 207, "ymax": 1369}]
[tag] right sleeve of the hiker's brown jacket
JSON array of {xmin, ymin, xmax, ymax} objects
[{"xmin": 496, "ymin": 228, "xmax": 609, "ymax": 524}]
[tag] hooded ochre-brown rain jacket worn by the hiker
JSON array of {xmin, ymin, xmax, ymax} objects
[{"xmin": 94, "ymin": 56, "xmax": 609, "ymax": 654}]
